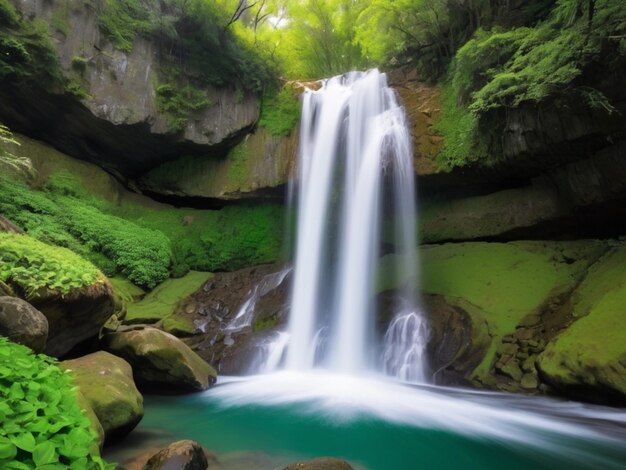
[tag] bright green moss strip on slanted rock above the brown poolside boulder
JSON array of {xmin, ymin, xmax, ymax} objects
[{"xmin": 124, "ymin": 271, "xmax": 211, "ymax": 324}]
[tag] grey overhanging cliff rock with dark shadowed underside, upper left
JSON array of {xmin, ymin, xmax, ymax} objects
[{"xmin": 0, "ymin": 0, "xmax": 259, "ymax": 176}]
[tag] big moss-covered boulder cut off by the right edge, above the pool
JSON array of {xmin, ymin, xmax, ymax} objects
[{"xmin": 537, "ymin": 246, "xmax": 626, "ymax": 405}]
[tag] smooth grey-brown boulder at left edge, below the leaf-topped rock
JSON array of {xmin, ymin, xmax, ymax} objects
[{"xmin": 0, "ymin": 297, "xmax": 48, "ymax": 353}]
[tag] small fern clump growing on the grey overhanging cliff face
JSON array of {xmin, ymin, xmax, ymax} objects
[{"xmin": 156, "ymin": 85, "xmax": 211, "ymax": 132}]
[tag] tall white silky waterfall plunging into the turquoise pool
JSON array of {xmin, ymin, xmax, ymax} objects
[{"xmin": 286, "ymin": 70, "xmax": 425, "ymax": 381}]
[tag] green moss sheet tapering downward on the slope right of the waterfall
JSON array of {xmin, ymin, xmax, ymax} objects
[{"xmin": 421, "ymin": 241, "xmax": 605, "ymax": 378}]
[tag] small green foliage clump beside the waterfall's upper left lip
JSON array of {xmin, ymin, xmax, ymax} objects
[{"xmin": 259, "ymin": 87, "xmax": 301, "ymax": 135}]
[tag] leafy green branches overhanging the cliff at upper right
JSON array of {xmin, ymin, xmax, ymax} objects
[{"xmin": 451, "ymin": 0, "xmax": 626, "ymax": 115}]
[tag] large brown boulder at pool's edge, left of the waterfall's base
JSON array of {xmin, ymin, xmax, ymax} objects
[{"xmin": 103, "ymin": 327, "xmax": 217, "ymax": 392}]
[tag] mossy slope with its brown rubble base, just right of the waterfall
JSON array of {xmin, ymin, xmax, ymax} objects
[{"xmin": 414, "ymin": 240, "xmax": 607, "ymax": 391}]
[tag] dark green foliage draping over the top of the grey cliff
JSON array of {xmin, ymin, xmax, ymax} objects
[{"xmin": 99, "ymin": 0, "xmax": 276, "ymax": 92}]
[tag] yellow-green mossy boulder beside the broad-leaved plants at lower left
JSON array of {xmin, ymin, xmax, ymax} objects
[{"xmin": 59, "ymin": 351, "xmax": 143, "ymax": 441}]
